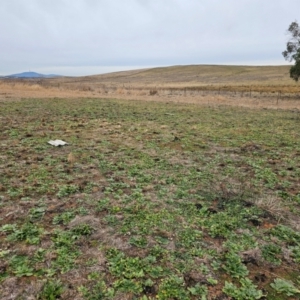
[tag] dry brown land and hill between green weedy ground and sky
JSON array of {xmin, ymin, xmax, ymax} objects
[{"xmin": 0, "ymin": 65, "xmax": 300, "ymax": 109}]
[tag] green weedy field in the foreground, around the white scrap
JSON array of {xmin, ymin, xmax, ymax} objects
[{"xmin": 0, "ymin": 99, "xmax": 300, "ymax": 299}]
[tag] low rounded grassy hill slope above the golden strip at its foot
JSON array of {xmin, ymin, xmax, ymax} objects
[{"xmin": 86, "ymin": 65, "xmax": 294, "ymax": 84}]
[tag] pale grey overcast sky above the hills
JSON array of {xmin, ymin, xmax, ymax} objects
[{"xmin": 0, "ymin": 0, "xmax": 300, "ymax": 76}]
